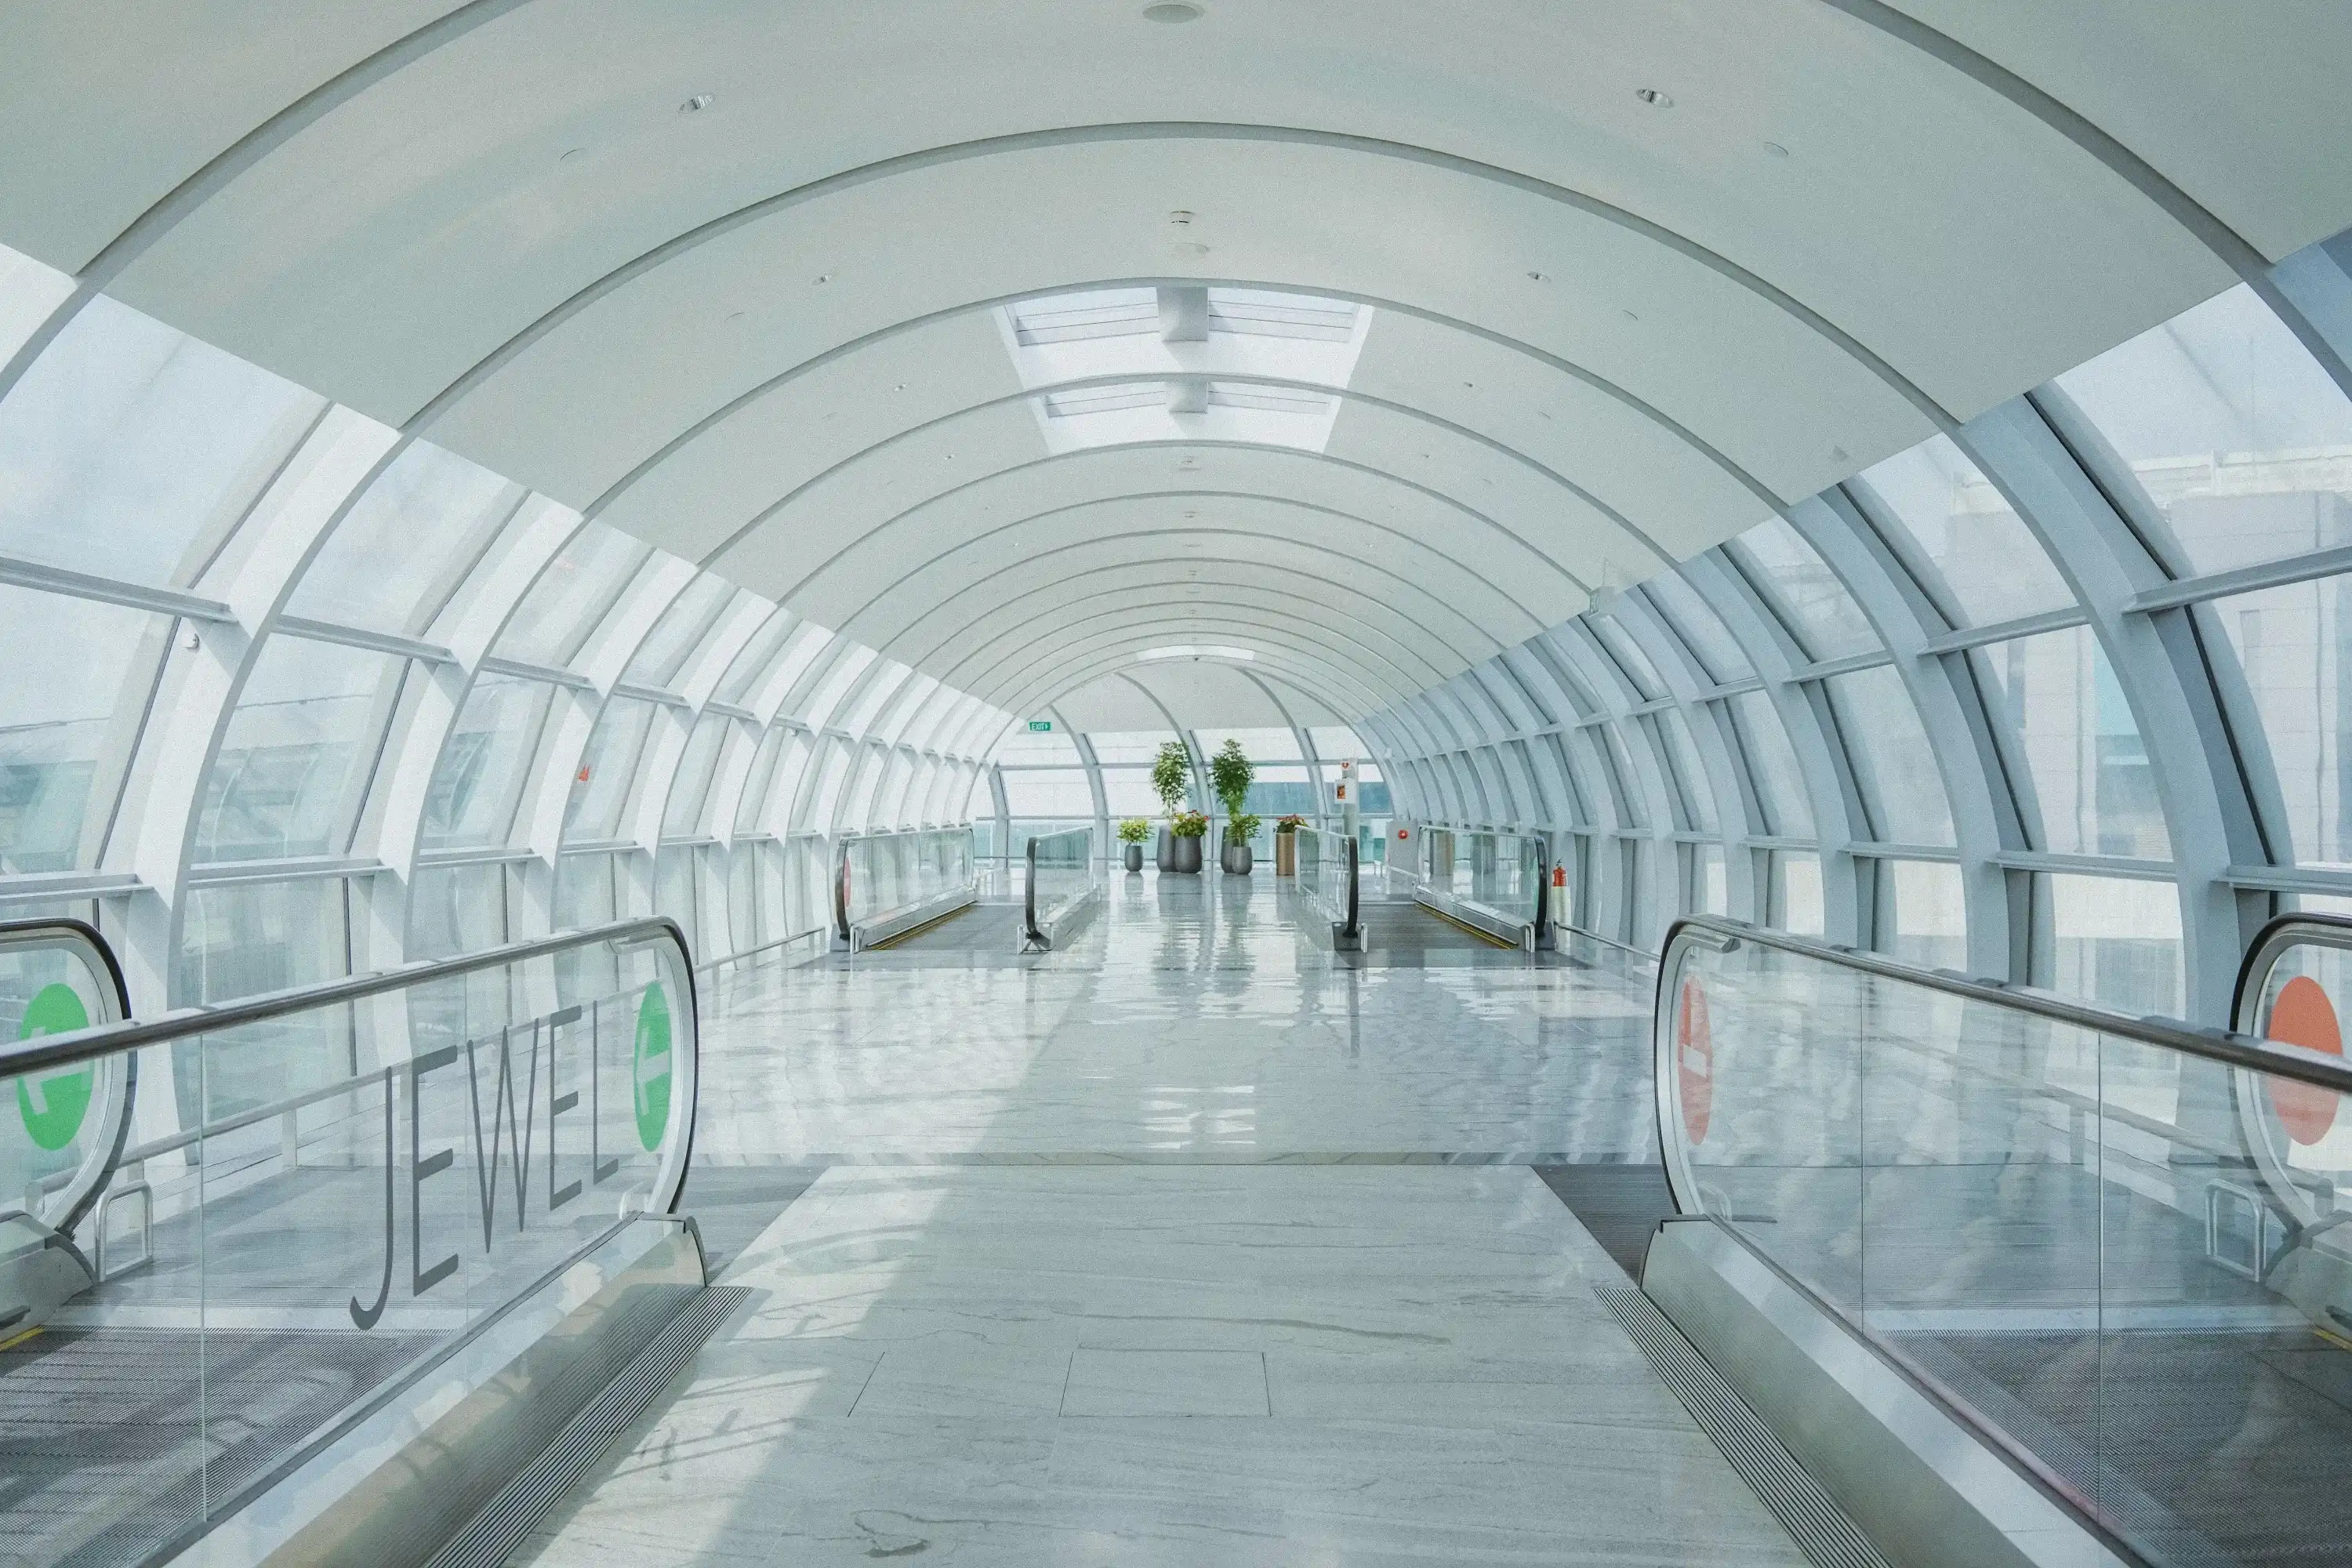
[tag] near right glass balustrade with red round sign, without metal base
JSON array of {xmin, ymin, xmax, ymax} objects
[{"xmin": 1656, "ymin": 919, "xmax": 2352, "ymax": 1563}]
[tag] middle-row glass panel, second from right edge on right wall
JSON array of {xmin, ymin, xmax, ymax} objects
[{"xmin": 1978, "ymin": 626, "xmax": 2173, "ymax": 860}]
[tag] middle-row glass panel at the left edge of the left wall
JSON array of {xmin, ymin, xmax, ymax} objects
[{"xmin": 0, "ymin": 586, "xmax": 169, "ymax": 872}]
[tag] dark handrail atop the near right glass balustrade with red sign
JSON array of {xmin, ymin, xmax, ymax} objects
[{"xmin": 1653, "ymin": 914, "xmax": 2352, "ymax": 1093}]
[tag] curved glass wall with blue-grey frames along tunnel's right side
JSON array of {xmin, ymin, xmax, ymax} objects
[{"xmin": 1359, "ymin": 223, "xmax": 2352, "ymax": 1022}]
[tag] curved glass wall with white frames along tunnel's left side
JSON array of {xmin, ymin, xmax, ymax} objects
[{"xmin": 0, "ymin": 232, "xmax": 1011, "ymax": 1013}]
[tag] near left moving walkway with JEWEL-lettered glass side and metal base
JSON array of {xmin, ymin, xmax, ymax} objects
[{"xmin": 0, "ymin": 919, "xmax": 722, "ymax": 1563}]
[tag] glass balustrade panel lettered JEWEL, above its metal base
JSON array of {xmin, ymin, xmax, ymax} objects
[{"xmin": 0, "ymin": 921, "xmax": 696, "ymax": 1566}]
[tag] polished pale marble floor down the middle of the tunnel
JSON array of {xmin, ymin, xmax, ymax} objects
[{"xmin": 515, "ymin": 874, "xmax": 1804, "ymax": 1568}]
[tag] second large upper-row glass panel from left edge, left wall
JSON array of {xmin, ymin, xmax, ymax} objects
[{"xmin": 287, "ymin": 442, "xmax": 522, "ymax": 637}]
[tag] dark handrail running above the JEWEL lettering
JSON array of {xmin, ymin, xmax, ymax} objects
[{"xmin": 0, "ymin": 914, "xmax": 701, "ymax": 1076}]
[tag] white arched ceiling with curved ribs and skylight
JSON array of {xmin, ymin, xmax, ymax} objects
[{"xmin": 0, "ymin": 0, "xmax": 2352, "ymax": 727}]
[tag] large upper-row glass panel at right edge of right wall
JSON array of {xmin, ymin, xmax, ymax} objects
[{"xmin": 2058, "ymin": 285, "xmax": 2352, "ymax": 576}]
